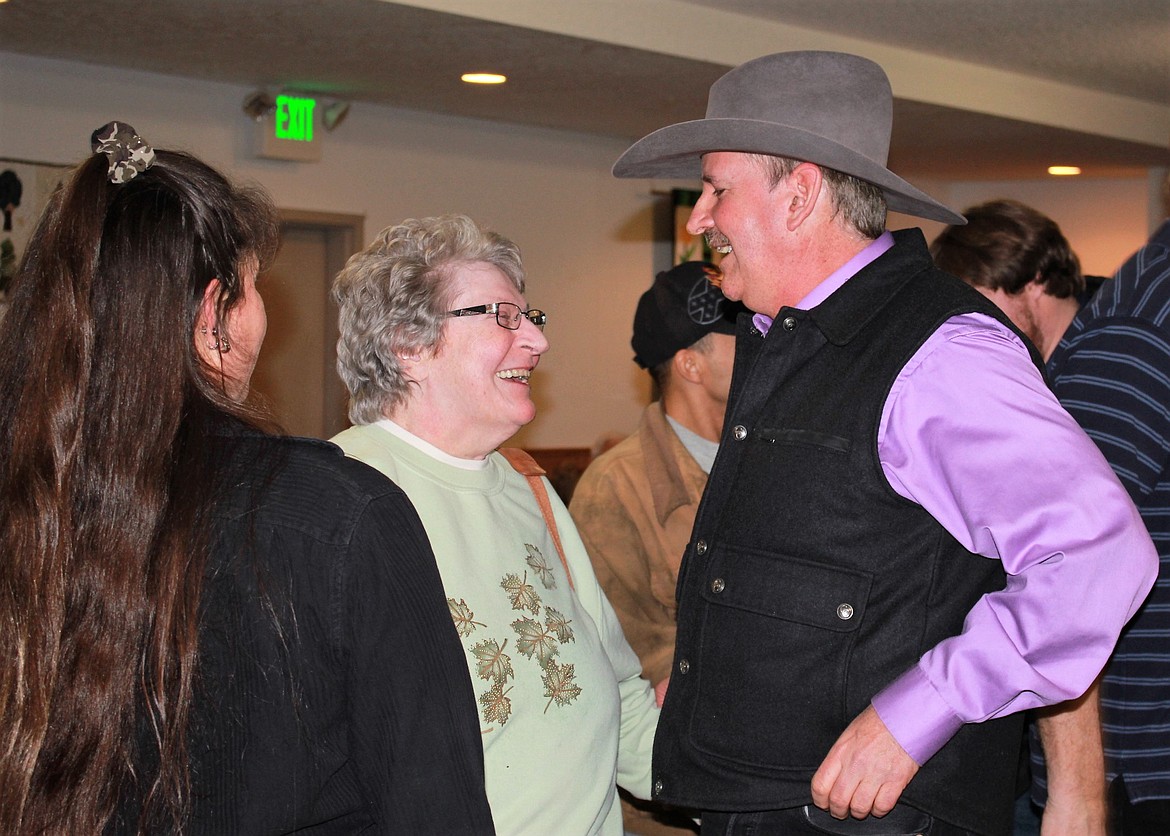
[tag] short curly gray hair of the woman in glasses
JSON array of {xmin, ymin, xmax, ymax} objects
[{"xmin": 332, "ymin": 215, "xmax": 524, "ymax": 424}]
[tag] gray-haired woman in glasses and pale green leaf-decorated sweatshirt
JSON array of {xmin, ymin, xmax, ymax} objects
[{"xmin": 333, "ymin": 215, "xmax": 658, "ymax": 836}]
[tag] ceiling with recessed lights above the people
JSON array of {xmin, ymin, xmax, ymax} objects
[{"xmin": 0, "ymin": 0, "xmax": 1170, "ymax": 179}]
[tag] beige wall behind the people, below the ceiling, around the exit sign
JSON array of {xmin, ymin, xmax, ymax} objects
[{"xmin": 0, "ymin": 54, "xmax": 1150, "ymax": 447}]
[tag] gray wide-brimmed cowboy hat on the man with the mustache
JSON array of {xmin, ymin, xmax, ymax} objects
[{"xmin": 613, "ymin": 51, "xmax": 965, "ymax": 223}]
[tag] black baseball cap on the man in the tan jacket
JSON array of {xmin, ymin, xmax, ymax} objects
[{"xmin": 629, "ymin": 261, "xmax": 746, "ymax": 368}]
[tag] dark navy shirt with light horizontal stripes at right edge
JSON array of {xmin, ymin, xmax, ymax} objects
[{"xmin": 1048, "ymin": 221, "xmax": 1170, "ymax": 802}]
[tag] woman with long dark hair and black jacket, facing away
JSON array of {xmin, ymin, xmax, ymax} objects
[{"xmin": 0, "ymin": 123, "xmax": 491, "ymax": 834}]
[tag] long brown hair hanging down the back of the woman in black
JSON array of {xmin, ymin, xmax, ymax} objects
[{"xmin": 0, "ymin": 151, "xmax": 277, "ymax": 834}]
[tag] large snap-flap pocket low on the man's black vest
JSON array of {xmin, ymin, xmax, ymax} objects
[{"xmin": 690, "ymin": 546, "xmax": 872, "ymax": 771}]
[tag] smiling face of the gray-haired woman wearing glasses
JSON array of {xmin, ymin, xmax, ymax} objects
[{"xmin": 412, "ymin": 262, "xmax": 549, "ymax": 458}]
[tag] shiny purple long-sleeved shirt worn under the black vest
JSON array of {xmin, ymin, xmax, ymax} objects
[{"xmin": 753, "ymin": 233, "xmax": 1158, "ymax": 765}]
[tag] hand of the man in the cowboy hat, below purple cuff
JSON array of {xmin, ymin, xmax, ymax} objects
[{"xmin": 812, "ymin": 705, "xmax": 918, "ymax": 818}]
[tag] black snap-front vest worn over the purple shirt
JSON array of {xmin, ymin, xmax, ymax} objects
[{"xmin": 654, "ymin": 230, "xmax": 1040, "ymax": 834}]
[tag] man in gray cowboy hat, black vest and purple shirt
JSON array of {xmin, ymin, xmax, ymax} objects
[{"xmin": 614, "ymin": 53, "xmax": 1157, "ymax": 836}]
